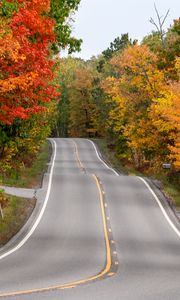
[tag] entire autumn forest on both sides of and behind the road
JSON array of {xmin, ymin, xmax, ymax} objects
[{"xmin": 0, "ymin": 0, "xmax": 180, "ymax": 193}]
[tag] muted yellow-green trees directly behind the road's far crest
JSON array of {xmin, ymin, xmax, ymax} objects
[{"xmin": 54, "ymin": 57, "xmax": 107, "ymax": 137}]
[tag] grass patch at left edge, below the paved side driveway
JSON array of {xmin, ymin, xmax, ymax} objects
[{"xmin": 0, "ymin": 196, "xmax": 36, "ymax": 247}]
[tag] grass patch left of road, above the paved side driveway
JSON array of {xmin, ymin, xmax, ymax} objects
[{"xmin": 0, "ymin": 142, "xmax": 51, "ymax": 188}]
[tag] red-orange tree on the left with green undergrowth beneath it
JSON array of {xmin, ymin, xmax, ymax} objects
[{"xmin": 0, "ymin": 0, "xmax": 58, "ymax": 171}]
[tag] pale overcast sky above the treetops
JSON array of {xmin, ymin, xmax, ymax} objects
[{"xmin": 64, "ymin": 0, "xmax": 180, "ymax": 60}]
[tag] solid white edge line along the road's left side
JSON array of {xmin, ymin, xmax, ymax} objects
[{"xmin": 0, "ymin": 140, "xmax": 56, "ymax": 259}]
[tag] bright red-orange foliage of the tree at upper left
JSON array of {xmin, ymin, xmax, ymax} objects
[{"xmin": 0, "ymin": 0, "xmax": 56, "ymax": 124}]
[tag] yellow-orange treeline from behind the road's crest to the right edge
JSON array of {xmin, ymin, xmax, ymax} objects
[{"xmin": 55, "ymin": 19, "xmax": 180, "ymax": 172}]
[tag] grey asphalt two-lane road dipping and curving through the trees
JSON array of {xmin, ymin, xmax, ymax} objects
[{"xmin": 0, "ymin": 139, "xmax": 180, "ymax": 300}]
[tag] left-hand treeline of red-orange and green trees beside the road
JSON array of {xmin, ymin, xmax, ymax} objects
[{"xmin": 0, "ymin": 0, "xmax": 81, "ymax": 177}]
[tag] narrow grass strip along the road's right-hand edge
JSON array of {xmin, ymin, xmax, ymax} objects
[{"xmin": 94, "ymin": 139, "xmax": 180, "ymax": 210}]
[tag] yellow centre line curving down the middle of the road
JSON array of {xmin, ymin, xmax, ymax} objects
[{"xmin": 0, "ymin": 145, "xmax": 114, "ymax": 297}]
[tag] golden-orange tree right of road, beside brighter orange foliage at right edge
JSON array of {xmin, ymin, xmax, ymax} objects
[{"xmin": 103, "ymin": 44, "xmax": 168, "ymax": 168}]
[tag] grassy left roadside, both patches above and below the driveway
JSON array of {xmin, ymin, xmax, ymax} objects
[{"xmin": 0, "ymin": 142, "xmax": 50, "ymax": 247}]
